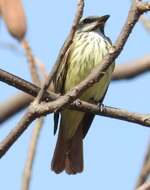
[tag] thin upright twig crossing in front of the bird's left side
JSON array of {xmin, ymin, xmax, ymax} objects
[{"xmin": 37, "ymin": 0, "xmax": 84, "ymax": 103}]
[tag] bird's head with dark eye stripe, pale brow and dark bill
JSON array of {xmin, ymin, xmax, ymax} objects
[{"xmin": 78, "ymin": 15, "xmax": 110, "ymax": 33}]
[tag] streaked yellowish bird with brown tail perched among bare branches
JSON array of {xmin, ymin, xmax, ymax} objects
[{"xmin": 51, "ymin": 15, "xmax": 115, "ymax": 174}]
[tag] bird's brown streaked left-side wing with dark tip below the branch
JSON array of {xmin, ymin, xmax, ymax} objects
[{"xmin": 53, "ymin": 45, "xmax": 71, "ymax": 135}]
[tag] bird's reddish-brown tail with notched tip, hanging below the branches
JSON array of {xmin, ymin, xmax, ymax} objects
[{"xmin": 51, "ymin": 125, "xmax": 83, "ymax": 174}]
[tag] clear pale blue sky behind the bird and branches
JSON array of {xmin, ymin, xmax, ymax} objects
[{"xmin": 0, "ymin": 0, "xmax": 150, "ymax": 190}]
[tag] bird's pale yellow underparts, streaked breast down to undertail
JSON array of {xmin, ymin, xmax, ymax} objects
[{"xmin": 62, "ymin": 32, "xmax": 114, "ymax": 139}]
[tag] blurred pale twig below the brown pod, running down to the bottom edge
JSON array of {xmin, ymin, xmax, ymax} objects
[{"xmin": 22, "ymin": 40, "xmax": 44, "ymax": 190}]
